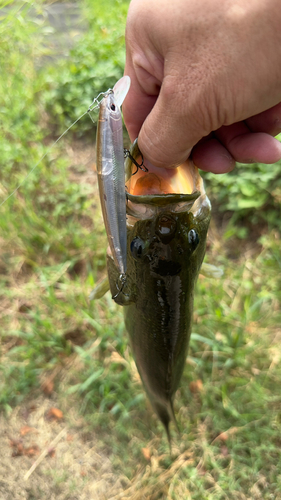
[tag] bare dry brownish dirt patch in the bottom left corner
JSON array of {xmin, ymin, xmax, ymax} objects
[{"xmin": 0, "ymin": 396, "xmax": 123, "ymax": 500}]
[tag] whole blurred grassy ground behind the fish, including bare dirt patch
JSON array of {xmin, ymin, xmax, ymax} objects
[{"xmin": 0, "ymin": 0, "xmax": 281, "ymax": 500}]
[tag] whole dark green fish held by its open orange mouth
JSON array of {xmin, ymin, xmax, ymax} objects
[{"xmin": 107, "ymin": 140, "xmax": 211, "ymax": 442}]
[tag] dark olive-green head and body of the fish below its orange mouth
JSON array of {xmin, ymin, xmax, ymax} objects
[{"xmin": 107, "ymin": 158, "xmax": 211, "ymax": 439}]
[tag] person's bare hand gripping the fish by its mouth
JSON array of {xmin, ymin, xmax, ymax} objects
[{"xmin": 123, "ymin": 0, "xmax": 281, "ymax": 173}]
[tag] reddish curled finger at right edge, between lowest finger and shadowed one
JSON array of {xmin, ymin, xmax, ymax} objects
[{"xmin": 215, "ymin": 122, "xmax": 281, "ymax": 164}]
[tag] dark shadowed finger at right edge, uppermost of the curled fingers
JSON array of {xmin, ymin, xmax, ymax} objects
[{"xmin": 246, "ymin": 103, "xmax": 281, "ymax": 136}]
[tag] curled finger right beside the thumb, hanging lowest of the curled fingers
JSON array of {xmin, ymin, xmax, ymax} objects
[{"xmin": 192, "ymin": 135, "xmax": 235, "ymax": 174}]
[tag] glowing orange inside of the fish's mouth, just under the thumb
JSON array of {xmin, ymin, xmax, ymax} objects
[{"xmin": 128, "ymin": 158, "xmax": 197, "ymax": 195}]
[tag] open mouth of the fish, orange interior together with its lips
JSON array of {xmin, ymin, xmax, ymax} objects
[{"xmin": 125, "ymin": 140, "xmax": 206, "ymax": 219}]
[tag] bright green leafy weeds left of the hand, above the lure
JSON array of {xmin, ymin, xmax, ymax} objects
[{"xmin": 43, "ymin": 0, "xmax": 129, "ymax": 136}]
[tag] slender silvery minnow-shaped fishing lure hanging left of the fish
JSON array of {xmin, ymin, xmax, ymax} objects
[{"xmin": 96, "ymin": 91, "xmax": 127, "ymax": 275}]
